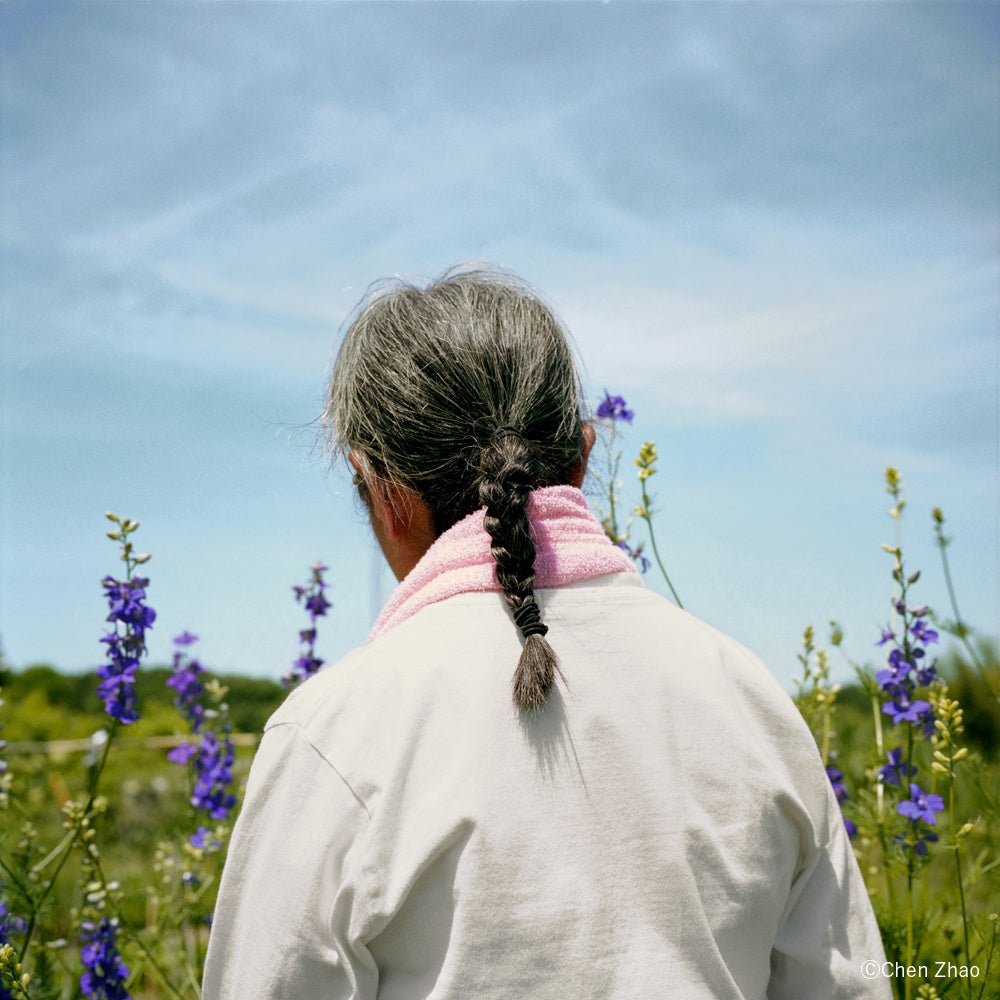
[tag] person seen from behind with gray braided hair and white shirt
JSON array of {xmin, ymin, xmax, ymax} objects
[{"xmin": 203, "ymin": 269, "xmax": 891, "ymax": 1000}]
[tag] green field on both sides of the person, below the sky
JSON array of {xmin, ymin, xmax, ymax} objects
[{"xmin": 0, "ymin": 651, "xmax": 1000, "ymax": 998}]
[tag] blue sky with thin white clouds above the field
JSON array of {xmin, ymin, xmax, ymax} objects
[{"xmin": 0, "ymin": 0, "xmax": 1000, "ymax": 689}]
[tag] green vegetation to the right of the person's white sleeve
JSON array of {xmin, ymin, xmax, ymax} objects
[{"xmin": 796, "ymin": 630, "xmax": 1000, "ymax": 1000}]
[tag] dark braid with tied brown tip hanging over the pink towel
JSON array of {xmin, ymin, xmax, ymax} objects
[{"xmin": 479, "ymin": 436, "xmax": 562, "ymax": 711}]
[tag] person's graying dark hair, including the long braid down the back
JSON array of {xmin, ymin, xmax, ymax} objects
[{"xmin": 324, "ymin": 262, "xmax": 582, "ymax": 709}]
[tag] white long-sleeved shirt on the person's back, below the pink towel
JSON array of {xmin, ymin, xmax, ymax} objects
[{"xmin": 204, "ymin": 574, "xmax": 891, "ymax": 1000}]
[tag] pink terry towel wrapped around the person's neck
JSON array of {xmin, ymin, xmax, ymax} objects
[{"xmin": 368, "ymin": 486, "xmax": 636, "ymax": 642}]
